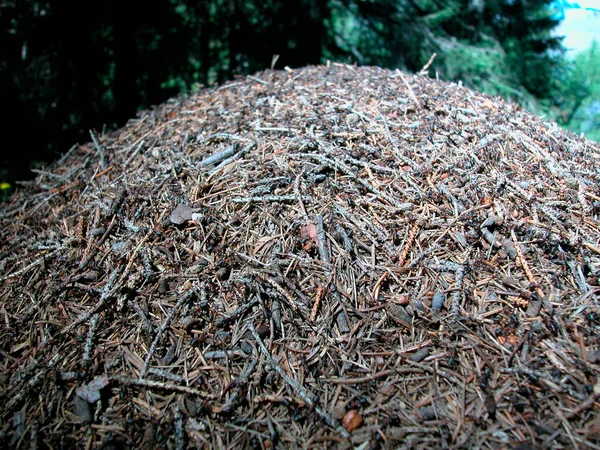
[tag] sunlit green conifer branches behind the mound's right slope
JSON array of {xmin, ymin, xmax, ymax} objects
[{"xmin": 330, "ymin": 0, "xmax": 562, "ymax": 108}]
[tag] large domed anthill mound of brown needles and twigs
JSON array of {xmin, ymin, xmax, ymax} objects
[{"xmin": 0, "ymin": 64, "xmax": 600, "ymax": 448}]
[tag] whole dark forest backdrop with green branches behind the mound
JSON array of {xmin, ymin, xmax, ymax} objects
[{"xmin": 0, "ymin": 0, "xmax": 600, "ymax": 192}]
